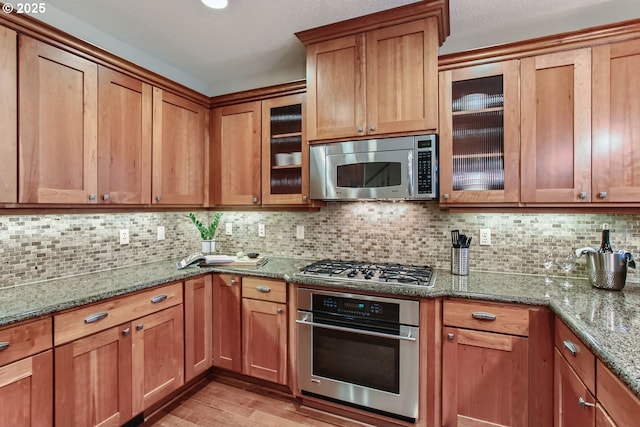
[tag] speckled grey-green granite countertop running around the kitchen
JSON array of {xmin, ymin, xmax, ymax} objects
[{"xmin": 0, "ymin": 257, "xmax": 640, "ymax": 397}]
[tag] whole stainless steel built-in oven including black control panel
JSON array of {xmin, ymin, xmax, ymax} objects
[{"xmin": 296, "ymin": 286, "xmax": 420, "ymax": 422}]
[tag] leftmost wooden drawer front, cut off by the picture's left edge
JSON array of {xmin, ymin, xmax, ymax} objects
[{"xmin": 0, "ymin": 317, "xmax": 53, "ymax": 366}]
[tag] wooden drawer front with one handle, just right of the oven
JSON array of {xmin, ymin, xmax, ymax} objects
[{"xmin": 443, "ymin": 301, "xmax": 529, "ymax": 336}]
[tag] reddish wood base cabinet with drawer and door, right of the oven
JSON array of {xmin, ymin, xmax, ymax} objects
[{"xmin": 442, "ymin": 301, "xmax": 552, "ymax": 427}]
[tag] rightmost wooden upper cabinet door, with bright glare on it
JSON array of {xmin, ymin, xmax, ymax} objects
[{"xmin": 591, "ymin": 39, "xmax": 640, "ymax": 203}]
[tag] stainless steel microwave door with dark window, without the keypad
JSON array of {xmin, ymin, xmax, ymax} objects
[{"xmin": 326, "ymin": 150, "xmax": 413, "ymax": 200}]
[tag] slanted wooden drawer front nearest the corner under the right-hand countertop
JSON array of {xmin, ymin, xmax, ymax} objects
[{"xmin": 554, "ymin": 317, "xmax": 596, "ymax": 395}]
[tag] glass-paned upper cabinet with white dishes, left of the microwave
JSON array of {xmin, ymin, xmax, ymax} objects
[{"xmin": 262, "ymin": 94, "xmax": 309, "ymax": 205}]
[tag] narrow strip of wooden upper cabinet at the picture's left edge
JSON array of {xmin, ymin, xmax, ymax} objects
[{"xmin": 0, "ymin": 26, "xmax": 18, "ymax": 203}]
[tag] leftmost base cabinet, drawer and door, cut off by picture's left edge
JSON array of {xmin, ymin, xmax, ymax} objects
[{"xmin": 0, "ymin": 318, "xmax": 53, "ymax": 427}]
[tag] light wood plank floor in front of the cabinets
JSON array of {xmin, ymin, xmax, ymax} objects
[{"xmin": 145, "ymin": 379, "xmax": 376, "ymax": 427}]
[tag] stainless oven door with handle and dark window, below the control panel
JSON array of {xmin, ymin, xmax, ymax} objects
[{"xmin": 296, "ymin": 310, "xmax": 419, "ymax": 422}]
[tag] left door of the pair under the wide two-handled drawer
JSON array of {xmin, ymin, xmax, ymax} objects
[{"xmin": 55, "ymin": 324, "xmax": 132, "ymax": 426}]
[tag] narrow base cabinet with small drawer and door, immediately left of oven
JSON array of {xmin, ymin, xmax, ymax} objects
[{"xmin": 242, "ymin": 277, "xmax": 288, "ymax": 384}]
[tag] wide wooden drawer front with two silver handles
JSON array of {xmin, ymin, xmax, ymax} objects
[{"xmin": 53, "ymin": 282, "xmax": 182, "ymax": 346}]
